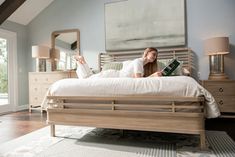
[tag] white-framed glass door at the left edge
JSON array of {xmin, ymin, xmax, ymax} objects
[{"xmin": 0, "ymin": 29, "xmax": 18, "ymax": 114}]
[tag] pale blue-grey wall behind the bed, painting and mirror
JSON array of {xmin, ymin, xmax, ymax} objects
[{"xmin": 28, "ymin": 0, "xmax": 235, "ymax": 79}]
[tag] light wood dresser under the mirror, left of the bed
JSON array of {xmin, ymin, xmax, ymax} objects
[{"xmin": 29, "ymin": 71, "xmax": 77, "ymax": 112}]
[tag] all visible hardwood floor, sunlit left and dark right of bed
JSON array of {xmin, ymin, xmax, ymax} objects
[{"xmin": 0, "ymin": 110, "xmax": 235, "ymax": 144}]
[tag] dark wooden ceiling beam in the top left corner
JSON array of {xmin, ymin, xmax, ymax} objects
[{"xmin": 0, "ymin": 0, "xmax": 26, "ymax": 25}]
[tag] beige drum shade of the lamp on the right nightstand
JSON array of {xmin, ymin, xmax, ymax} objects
[{"xmin": 204, "ymin": 37, "xmax": 229, "ymax": 55}]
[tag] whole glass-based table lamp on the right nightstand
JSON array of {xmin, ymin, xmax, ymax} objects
[{"xmin": 204, "ymin": 37, "xmax": 229, "ymax": 80}]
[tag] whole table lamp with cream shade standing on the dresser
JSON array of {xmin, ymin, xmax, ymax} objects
[{"xmin": 32, "ymin": 45, "xmax": 50, "ymax": 72}]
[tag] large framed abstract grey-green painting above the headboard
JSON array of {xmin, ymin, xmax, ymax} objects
[{"xmin": 105, "ymin": 0, "xmax": 186, "ymax": 52}]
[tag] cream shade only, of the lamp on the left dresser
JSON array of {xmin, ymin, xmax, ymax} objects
[{"xmin": 32, "ymin": 45, "xmax": 50, "ymax": 58}]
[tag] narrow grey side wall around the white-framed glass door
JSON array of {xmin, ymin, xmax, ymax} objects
[{"xmin": 0, "ymin": 21, "xmax": 29, "ymax": 106}]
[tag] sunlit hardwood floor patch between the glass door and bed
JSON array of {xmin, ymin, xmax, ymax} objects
[{"xmin": 0, "ymin": 110, "xmax": 46, "ymax": 144}]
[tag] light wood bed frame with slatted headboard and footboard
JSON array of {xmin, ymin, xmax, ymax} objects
[{"xmin": 47, "ymin": 48, "xmax": 206, "ymax": 149}]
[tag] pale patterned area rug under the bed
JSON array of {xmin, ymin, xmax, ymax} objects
[{"xmin": 0, "ymin": 126, "xmax": 235, "ymax": 157}]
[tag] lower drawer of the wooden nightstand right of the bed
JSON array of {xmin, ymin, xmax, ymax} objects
[{"xmin": 215, "ymin": 96, "xmax": 235, "ymax": 112}]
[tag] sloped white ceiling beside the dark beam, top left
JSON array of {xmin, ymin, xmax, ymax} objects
[{"xmin": 6, "ymin": 0, "xmax": 54, "ymax": 25}]
